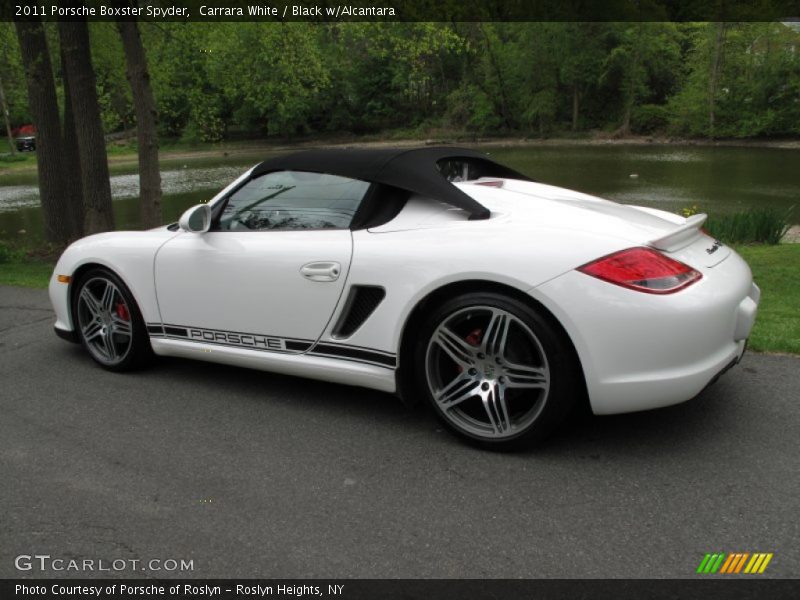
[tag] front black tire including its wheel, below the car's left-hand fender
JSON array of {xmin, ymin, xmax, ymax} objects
[{"xmin": 71, "ymin": 267, "xmax": 153, "ymax": 372}]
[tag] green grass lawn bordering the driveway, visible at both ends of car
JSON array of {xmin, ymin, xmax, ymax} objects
[{"xmin": 0, "ymin": 244, "xmax": 800, "ymax": 354}]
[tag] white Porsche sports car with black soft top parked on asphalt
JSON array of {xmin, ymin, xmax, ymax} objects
[{"xmin": 50, "ymin": 148, "xmax": 759, "ymax": 447}]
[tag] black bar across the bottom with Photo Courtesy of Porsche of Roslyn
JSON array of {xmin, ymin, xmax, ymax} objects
[{"xmin": 0, "ymin": 576, "xmax": 800, "ymax": 600}]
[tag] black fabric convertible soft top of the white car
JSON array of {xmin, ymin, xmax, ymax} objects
[{"xmin": 252, "ymin": 147, "xmax": 530, "ymax": 219}]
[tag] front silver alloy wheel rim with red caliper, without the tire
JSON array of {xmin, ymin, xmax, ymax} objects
[{"xmin": 77, "ymin": 277, "xmax": 133, "ymax": 365}]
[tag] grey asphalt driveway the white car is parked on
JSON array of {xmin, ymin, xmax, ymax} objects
[{"xmin": 0, "ymin": 287, "xmax": 800, "ymax": 578}]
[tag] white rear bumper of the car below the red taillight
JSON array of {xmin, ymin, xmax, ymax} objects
[{"xmin": 531, "ymin": 247, "xmax": 760, "ymax": 414}]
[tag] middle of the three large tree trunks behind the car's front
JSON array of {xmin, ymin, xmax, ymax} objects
[{"xmin": 58, "ymin": 20, "xmax": 114, "ymax": 234}]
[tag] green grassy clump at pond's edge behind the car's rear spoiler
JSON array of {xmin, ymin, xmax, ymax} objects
[{"xmin": 705, "ymin": 208, "xmax": 790, "ymax": 244}]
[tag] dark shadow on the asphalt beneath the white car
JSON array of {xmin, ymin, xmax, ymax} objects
[{"xmin": 133, "ymin": 358, "xmax": 735, "ymax": 455}]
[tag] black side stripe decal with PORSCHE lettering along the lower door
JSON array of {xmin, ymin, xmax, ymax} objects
[{"xmin": 147, "ymin": 323, "xmax": 397, "ymax": 369}]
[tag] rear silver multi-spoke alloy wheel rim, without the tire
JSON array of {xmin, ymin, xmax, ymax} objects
[{"xmin": 425, "ymin": 306, "xmax": 550, "ymax": 439}]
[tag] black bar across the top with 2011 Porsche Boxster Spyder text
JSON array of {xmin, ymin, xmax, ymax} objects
[{"xmin": 0, "ymin": 0, "xmax": 800, "ymax": 22}]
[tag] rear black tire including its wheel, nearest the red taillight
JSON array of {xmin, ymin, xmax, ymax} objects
[{"xmin": 414, "ymin": 292, "xmax": 583, "ymax": 450}]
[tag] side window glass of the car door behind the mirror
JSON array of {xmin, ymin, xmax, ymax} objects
[{"xmin": 214, "ymin": 171, "xmax": 369, "ymax": 231}]
